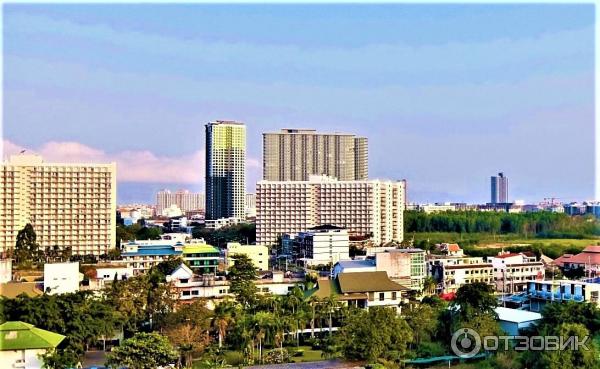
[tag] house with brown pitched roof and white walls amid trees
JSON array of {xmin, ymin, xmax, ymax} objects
[{"xmin": 305, "ymin": 271, "xmax": 408, "ymax": 312}]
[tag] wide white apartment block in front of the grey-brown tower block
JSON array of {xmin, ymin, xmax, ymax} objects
[{"xmin": 256, "ymin": 176, "xmax": 405, "ymax": 245}]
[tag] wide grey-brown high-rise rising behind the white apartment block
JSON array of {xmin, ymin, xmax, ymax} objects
[{"xmin": 263, "ymin": 129, "xmax": 369, "ymax": 181}]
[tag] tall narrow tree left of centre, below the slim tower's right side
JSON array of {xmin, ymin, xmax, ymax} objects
[{"xmin": 229, "ymin": 254, "xmax": 257, "ymax": 308}]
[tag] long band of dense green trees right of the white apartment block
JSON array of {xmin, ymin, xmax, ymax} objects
[{"xmin": 404, "ymin": 210, "xmax": 600, "ymax": 238}]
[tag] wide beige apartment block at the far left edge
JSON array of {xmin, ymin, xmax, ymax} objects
[{"xmin": 0, "ymin": 154, "xmax": 117, "ymax": 255}]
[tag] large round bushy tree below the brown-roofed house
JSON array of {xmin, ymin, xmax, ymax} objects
[{"xmin": 339, "ymin": 307, "xmax": 412, "ymax": 361}]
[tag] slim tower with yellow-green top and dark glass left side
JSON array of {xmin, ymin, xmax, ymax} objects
[{"xmin": 206, "ymin": 120, "xmax": 246, "ymax": 219}]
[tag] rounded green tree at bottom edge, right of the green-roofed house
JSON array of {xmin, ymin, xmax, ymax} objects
[{"xmin": 107, "ymin": 333, "xmax": 179, "ymax": 369}]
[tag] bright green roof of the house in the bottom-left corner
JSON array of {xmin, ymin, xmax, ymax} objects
[{"xmin": 0, "ymin": 321, "xmax": 65, "ymax": 351}]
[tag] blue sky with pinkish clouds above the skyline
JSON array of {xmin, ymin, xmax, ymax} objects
[{"xmin": 3, "ymin": 4, "xmax": 594, "ymax": 202}]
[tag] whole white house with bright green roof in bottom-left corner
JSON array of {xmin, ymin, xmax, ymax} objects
[{"xmin": 0, "ymin": 321, "xmax": 65, "ymax": 369}]
